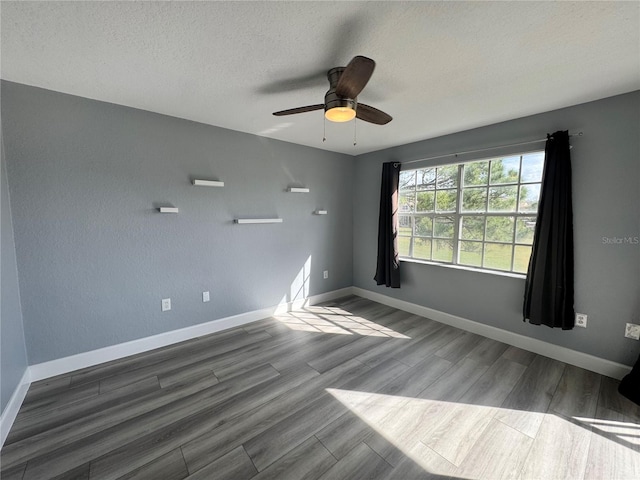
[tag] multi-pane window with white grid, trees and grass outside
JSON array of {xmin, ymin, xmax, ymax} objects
[{"xmin": 398, "ymin": 152, "xmax": 544, "ymax": 273}]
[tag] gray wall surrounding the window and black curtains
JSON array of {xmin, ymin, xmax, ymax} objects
[{"xmin": 353, "ymin": 92, "xmax": 640, "ymax": 365}]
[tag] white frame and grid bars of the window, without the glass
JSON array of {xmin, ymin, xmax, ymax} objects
[{"xmin": 398, "ymin": 150, "xmax": 544, "ymax": 276}]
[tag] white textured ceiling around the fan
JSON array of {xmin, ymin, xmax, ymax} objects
[{"xmin": 0, "ymin": 1, "xmax": 640, "ymax": 155}]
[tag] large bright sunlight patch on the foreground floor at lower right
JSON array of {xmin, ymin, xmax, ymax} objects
[{"xmin": 327, "ymin": 388, "xmax": 640, "ymax": 479}]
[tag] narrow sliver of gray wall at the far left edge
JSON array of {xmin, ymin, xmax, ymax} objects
[{"xmin": 0, "ymin": 121, "xmax": 27, "ymax": 412}]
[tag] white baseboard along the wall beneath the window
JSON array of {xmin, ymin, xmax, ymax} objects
[{"xmin": 351, "ymin": 287, "xmax": 631, "ymax": 380}]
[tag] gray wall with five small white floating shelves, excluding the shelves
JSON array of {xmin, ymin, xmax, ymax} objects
[{"xmin": 2, "ymin": 82, "xmax": 354, "ymax": 364}]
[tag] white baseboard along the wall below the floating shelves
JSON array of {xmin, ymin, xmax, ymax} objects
[{"xmin": 29, "ymin": 287, "xmax": 351, "ymax": 382}]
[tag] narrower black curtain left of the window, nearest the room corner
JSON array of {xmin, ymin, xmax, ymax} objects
[{"xmin": 373, "ymin": 162, "xmax": 400, "ymax": 288}]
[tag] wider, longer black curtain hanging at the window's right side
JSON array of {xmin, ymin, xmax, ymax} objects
[{"xmin": 523, "ymin": 131, "xmax": 575, "ymax": 330}]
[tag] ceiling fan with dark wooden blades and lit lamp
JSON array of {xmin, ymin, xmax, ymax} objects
[{"xmin": 273, "ymin": 56, "xmax": 392, "ymax": 125}]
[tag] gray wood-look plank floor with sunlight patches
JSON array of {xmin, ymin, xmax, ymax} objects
[{"xmin": 0, "ymin": 297, "xmax": 640, "ymax": 480}]
